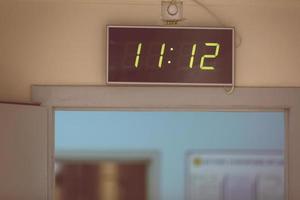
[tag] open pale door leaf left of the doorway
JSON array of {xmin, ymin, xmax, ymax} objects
[{"xmin": 0, "ymin": 103, "xmax": 49, "ymax": 200}]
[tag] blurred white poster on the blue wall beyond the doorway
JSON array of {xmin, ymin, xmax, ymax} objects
[{"xmin": 187, "ymin": 151, "xmax": 284, "ymax": 200}]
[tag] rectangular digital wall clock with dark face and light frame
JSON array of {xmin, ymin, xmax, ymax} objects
[{"xmin": 107, "ymin": 26, "xmax": 234, "ymax": 86}]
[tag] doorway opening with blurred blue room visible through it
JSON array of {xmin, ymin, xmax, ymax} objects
[{"xmin": 55, "ymin": 110, "xmax": 286, "ymax": 200}]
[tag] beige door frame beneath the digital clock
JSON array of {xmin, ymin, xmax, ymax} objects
[{"xmin": 31, "ymin": 85, "xmax": 300, "ymax": 200}]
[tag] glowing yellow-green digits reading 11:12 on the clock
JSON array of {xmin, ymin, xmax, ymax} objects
[{"xmin": 134, "ymin": 42, "xmax": 220, "ymax": 71}]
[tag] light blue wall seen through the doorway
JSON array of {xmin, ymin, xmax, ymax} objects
[{"xmin": 55, "ymin": 111, "xmax": 285, "ymax": 200}]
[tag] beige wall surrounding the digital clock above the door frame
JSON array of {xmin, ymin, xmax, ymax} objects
[{"xmin": 0, "ymin": 0, "xmax": 300, "ymax": 101}]
